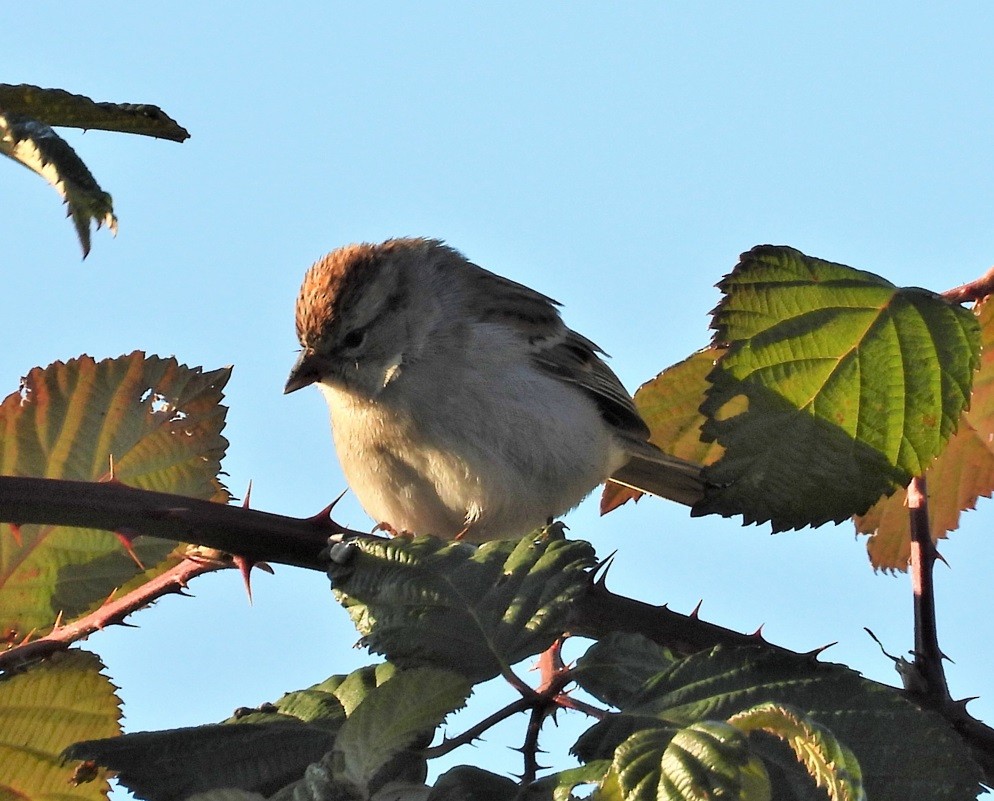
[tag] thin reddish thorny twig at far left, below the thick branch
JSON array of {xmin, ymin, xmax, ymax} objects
[{"xmin": 0, "ymin": 559, "xmax": 224, "ymax": 671}]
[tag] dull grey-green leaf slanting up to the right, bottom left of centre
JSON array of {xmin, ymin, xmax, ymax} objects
[{"xmin": 335, "ymin": 668, "xmax": 472, "ymax": 789}]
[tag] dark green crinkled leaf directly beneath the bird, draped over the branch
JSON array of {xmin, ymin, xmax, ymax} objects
[{"xmin": 328, "ymin": 537, "xmax": 594, "ymax": 683}]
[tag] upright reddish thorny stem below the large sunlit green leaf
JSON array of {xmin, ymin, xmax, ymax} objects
[{"xmin": 907, "ymin": 476, "xmax": 950, "ymax": 704}]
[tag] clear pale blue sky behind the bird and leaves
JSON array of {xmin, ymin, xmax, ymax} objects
[{"xmin": 0, "ymin": 2, "xmax": 994, "ymax": 792}]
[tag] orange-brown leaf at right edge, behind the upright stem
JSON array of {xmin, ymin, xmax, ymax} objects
[{"xmin": 855, "ymin": 300, "xmax": 994, "ymax": 570}]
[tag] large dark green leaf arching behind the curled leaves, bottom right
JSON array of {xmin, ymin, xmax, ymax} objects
[{"xmin": 574, "ymin": 647, "xmax": 981, "ymax": 801}]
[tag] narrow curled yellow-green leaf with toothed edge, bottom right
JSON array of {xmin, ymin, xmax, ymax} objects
[{"xmin": 728, "ymin": 703, "xmax": 866, "ymax": 801}]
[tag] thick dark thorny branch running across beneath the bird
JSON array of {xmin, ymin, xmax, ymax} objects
[{"xmin": 0, "ymin": 476, "xmax": 994, "ymax": 782}]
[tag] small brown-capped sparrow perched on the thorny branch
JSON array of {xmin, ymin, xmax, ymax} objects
[{"xmin": 285, "ymin": 234, "xmax": 702, "ymax": 542}]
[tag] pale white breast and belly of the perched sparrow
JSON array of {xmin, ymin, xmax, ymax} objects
[{"xmin": 320, "ymin": 340, "xmax": 628, "ymax": 542}]
